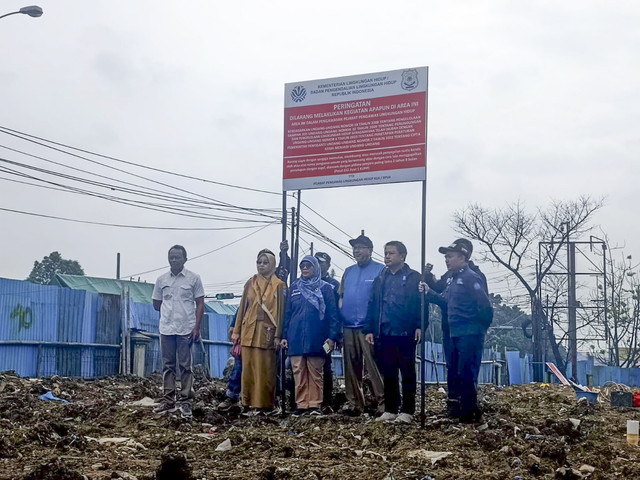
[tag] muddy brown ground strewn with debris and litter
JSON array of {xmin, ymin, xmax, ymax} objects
[{"xmin": 0, "ymin": 372, "xmax": 640, "ymax": 480}]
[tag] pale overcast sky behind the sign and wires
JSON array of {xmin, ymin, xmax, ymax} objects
[{"xmin": 0, "ymin": 0, "xmax": 640, "ymax": 306}]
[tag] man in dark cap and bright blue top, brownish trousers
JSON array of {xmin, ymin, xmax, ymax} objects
[{"xmin": 339, "ymin": 235, "xmax": 384, "ymax": 415}]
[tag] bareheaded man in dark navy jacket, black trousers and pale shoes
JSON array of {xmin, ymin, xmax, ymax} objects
[{"xmin": 363, "ymin": 240, "xmax": 422, "ymax": 423}]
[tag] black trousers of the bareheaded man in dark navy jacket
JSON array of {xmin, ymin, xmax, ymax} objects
[{"xmin": 375, "ymin": 335, "xmax": 416, "ymax": 415}]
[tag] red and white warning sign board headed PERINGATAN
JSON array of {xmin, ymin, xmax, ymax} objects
[{"xmin": 283, "ymin": 67, "xmax": 428, "ymax": 191}]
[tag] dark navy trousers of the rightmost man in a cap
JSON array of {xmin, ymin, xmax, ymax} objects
[{"xmin": 447, "ymin": 334, "xmax": 484, "ymax": 416}]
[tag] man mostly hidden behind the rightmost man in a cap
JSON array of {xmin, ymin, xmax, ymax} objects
[{"xmin": 424, "ymin": 238, "xmax": 489, "ymax": 418}]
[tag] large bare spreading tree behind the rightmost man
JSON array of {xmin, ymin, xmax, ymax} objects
[{"xmin": 453, "ymin": 195, "xmax": 604, "ymax": 381}]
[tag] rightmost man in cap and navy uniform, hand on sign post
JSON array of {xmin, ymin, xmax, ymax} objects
[{"xmin": 420, "ymin": 239, "xmax": 493, "ymax": 423}]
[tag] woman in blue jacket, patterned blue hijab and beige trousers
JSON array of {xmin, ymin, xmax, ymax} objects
[{"xmin": 281, "ymin": 255, "xmax": 340, "ymax": 415}]
